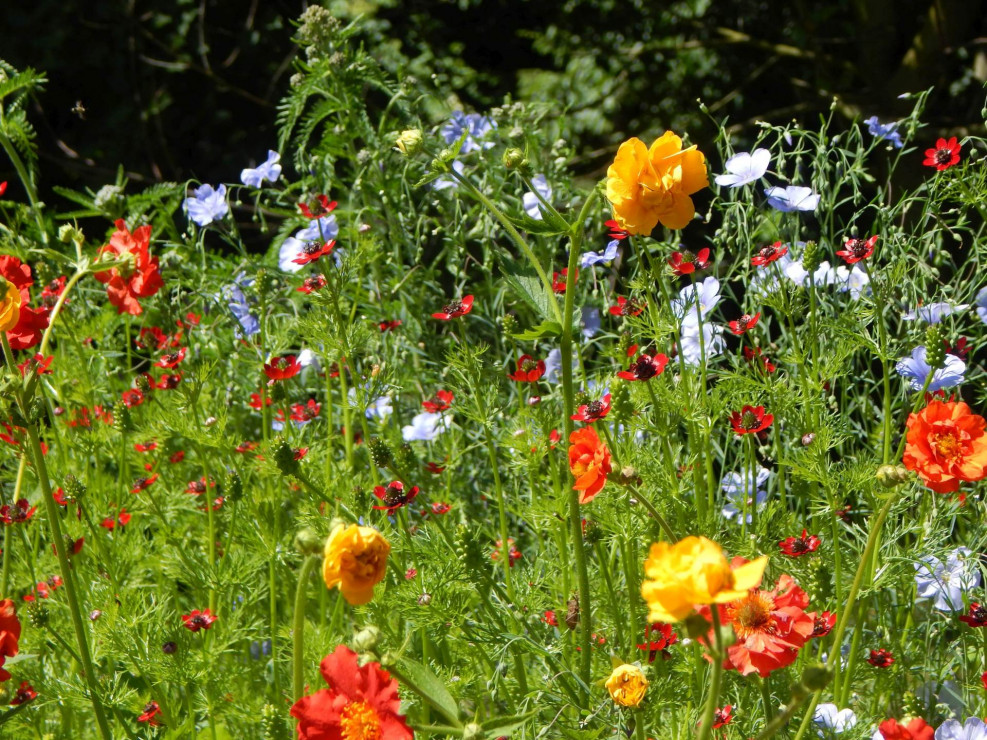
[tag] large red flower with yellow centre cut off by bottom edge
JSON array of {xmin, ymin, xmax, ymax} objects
[{"xmin": 291, "ymin": 645, "xmax": 414, "ymax": 740}]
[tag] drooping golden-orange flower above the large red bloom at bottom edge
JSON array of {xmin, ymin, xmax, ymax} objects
[{"xmin": 322, "ymin": 524, "xmax": 391, "ymax": 605}]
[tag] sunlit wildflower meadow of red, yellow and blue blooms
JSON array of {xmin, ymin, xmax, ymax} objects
[{"xmin": 0, "ymin": 5, "xmax": 987, "ymax": 740}]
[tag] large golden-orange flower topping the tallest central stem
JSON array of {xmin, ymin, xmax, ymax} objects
[{"xmin": 607, "ymin": 131, "xmax": 709, "ymax": 236}]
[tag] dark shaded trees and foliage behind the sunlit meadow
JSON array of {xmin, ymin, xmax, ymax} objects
[{"xmin": 0, "ymin": 0, "xmax": 987, "ymax": 192}]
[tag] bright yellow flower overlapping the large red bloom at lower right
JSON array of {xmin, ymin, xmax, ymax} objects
[{"xmin": 641, "ymin": 537, "xmax": 768, "ymax": 622}]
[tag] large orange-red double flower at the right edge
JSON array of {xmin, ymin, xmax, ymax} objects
[{"xmin": 902, "ymin": 400, "xmax": 987, "ymax": 493}]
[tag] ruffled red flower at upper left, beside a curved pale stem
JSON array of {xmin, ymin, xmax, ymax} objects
[{"xmin": 93, "ymin": 219, "xmax": 164, "ymax": 316}]
